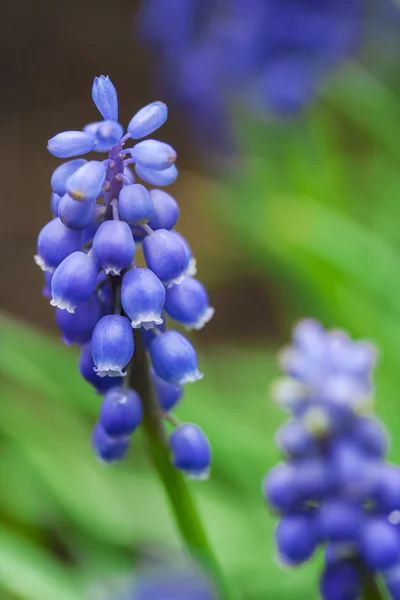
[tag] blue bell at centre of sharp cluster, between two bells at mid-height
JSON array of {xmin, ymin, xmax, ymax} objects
[{"xmin": 92, "ymin": 221, "xmax": 136, "ymax": 275}]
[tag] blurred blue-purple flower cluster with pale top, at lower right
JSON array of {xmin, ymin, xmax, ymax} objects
[{"xmin": 264, "ymin": 320, "xmax": 400, "ymax": 600}]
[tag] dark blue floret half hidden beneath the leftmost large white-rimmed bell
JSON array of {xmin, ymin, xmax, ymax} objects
[{"xmin": 56, "ymin": 294, "xmax": 103, "ymax": 344}]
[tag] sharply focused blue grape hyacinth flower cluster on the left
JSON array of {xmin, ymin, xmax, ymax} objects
[{"xmin": 35, "ymin": 76, "xmax": 214, "ymax": 475}]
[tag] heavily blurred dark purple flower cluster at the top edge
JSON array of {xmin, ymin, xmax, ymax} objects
[{"xmin": 136, "ymin": 0, "xmax": 364, "ymax": 144}]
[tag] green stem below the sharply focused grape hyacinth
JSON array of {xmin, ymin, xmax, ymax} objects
[{"xmin": 129, "ymin": 329, "xmax": 237, "ymax": 600}]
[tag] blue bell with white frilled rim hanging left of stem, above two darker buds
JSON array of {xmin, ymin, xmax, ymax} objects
[{"xmin": 92, "ymin": 315, "xmax": 134, "ymax": 377}]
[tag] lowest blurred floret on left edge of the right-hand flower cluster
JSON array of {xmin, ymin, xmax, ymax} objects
[{"xmin": 275, "ymin": 511, "xmax": 318, "ymax": 565}]
